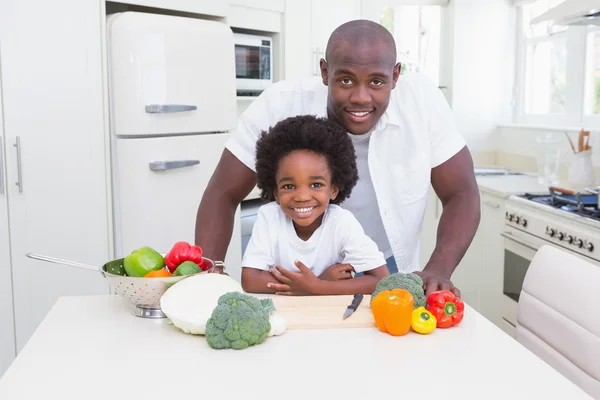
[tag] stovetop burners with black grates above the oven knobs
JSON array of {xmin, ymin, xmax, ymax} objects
[{"xmin": 517, "ymin": 192, "xmax": 600, "ymax": 221}]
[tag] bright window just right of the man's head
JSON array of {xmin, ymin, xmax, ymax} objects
[{"xmin": 380, "ymin": 5, "xmax": 441, "ymax": 84}]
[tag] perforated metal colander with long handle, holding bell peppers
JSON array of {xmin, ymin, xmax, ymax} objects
[{"xmin": 25, "ymin": 253, "xmax": 215, "ymax": 318}]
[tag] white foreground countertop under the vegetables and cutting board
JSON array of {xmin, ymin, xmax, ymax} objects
[{"xmin": 0, "ymin": 296, "xmax": 590, "ymax": 400}]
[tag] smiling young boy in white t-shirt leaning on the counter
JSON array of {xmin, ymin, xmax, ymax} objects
[{"xmin": 242, "ymin": 116, "xmax": 389, "ymax": 295}]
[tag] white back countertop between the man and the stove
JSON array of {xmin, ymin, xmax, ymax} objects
[{"xmin": 477, "ymin": 175, "xmax": 549, "ymax": 197}]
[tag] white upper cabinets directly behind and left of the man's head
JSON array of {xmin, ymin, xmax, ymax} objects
[{"xmin": 284, "ymin": 0, "xmax": 362, "ymax": 79}]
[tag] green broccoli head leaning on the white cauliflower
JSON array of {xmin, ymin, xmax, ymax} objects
[{"xmin": 205, "ymin": 292, "xmax": 272, "ymax": 350}]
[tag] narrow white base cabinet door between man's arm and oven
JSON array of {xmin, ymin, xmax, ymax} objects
[{"xmin": 480, "ymin": 193, "xmax": 505, "ymax": 327}]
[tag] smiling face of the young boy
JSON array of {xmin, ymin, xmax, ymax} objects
[{"xmin": 274, "ymin": 150, "xmax": 338, "ymax": 240}]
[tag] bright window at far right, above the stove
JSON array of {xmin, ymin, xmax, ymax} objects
[{"xmin": 515, "ymin": 0, "xmax": 600, "ymax": 128}]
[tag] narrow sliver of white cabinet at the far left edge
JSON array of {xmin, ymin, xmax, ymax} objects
[{"xmin": 0, "ymin": 79, "xmax": 15, "ymax": 376}]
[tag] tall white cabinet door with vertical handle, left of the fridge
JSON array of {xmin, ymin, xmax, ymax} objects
[{"xmin": 0, "ymin": 0, "xmax": 111, "ymax": 351}]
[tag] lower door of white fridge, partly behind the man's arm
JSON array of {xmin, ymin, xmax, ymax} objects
[{"xmin": 115, "ymin": 133, "xmax": 241, "ymax": 280}]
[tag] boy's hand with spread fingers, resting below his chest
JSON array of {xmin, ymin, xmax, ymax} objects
[{"xmin": 267, "ymin": 260, "xmax": 322, "ymax": 296}]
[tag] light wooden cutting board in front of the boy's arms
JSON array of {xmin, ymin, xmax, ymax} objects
[{"xmin": 256, "ymin": 295, "xmax": 375, "ymax": 329}]
